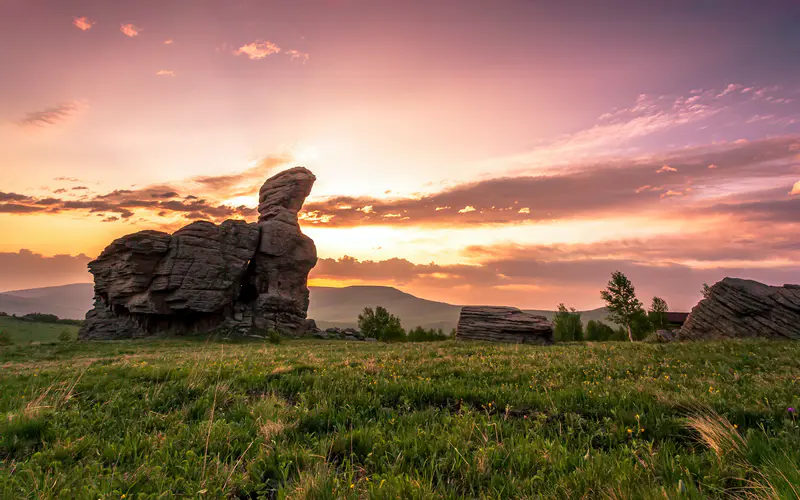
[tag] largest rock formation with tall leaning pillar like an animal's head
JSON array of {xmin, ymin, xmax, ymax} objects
[{"xmin": 80, "ymin": 167, "xmax": 317, "ymax": 339}]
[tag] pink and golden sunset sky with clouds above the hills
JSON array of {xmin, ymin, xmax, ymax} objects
[{"xmin": 0, "ymin": 0, "xmax": 800, "ymax": 310}]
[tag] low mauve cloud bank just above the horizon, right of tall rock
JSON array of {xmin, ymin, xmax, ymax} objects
[{"xmin": 310, "ymin": 232, "xmax": 800, "ymax": 310}]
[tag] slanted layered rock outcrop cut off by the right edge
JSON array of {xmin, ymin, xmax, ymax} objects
[{"xmin": 678, "ymin": 278, "xmax": 800, "ymax": 340}]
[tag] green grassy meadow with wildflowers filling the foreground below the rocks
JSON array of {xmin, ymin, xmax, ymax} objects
[{"xmin": 0, "ymin": 340, "xmax": 800, "ymax": 499}]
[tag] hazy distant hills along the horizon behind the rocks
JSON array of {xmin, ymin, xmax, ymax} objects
[{"xmin": 0, "ymin": 283, "xmax": 620, "ymax": 332}]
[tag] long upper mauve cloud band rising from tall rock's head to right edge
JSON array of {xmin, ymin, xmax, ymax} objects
[{"xmin": 303, "ymin": 137, "xmax": 800, "ymax": 226}]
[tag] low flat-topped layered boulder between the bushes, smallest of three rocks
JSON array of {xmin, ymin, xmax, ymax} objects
[{"xmin": 456, "ymin": 306, "xmax": 553, "ymax": 344}]
